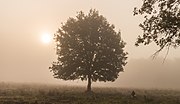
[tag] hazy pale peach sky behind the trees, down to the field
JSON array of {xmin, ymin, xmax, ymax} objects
[{"xmin": 0, "ymin": 0, "xmax": 180, "ymax": 87}]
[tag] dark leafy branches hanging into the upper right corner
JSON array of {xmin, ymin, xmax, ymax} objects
[{"xmin": 134, "ymin": 0, "xmax": 180, "ymax": 56}]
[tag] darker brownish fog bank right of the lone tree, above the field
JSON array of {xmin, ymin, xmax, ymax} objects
[{"xmin": 117, "ymin": 58, "xmax": 180, "ymax": 89}]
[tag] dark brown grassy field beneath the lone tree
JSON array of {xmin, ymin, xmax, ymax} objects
[{"xmin": 0, "ymin": 83, "xmax": 180, "ymax": 104}]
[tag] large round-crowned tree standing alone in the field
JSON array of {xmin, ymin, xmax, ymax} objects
[{"xmin": 50, "ymin": 9, "xmax": 127, "ymax": 92}]
